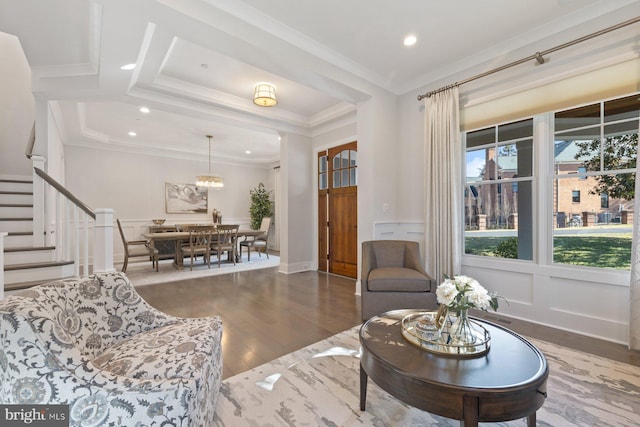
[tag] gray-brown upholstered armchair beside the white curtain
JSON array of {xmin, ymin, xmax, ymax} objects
[{"xmin": 360, "ymin": 240, "xmax": 438, "ymax": 320}]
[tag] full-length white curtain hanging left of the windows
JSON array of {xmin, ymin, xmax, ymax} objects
[{"xmin": 424, "ymin": 87, "xmax": 462, "ymax": 283}]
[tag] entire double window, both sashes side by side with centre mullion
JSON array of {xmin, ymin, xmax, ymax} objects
[{"xmin": 464, "ymin": 94, "xmax": 640, "ymax": 270}]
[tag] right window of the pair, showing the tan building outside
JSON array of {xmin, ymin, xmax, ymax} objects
[{"xmin": 553, "ymin": 95, "xmax": 640, "ymax": 269}]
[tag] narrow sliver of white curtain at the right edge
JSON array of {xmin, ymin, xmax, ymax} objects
[{"xmin": 629, "ymin": 164, "xmax": 640, "ymax": 350}]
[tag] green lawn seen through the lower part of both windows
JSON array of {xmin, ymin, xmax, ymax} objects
[{"xmin": 465, "ymin": 233, "xmax": 631, "ymax": 270}]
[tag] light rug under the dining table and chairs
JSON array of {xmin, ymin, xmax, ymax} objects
[{"xmin": 126, "ymin": 252, "xmax": 280, "ymax": 286}]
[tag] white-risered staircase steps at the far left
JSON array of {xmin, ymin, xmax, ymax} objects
[{"xmin": 0, "ymin": 178, "xmax": 74, "ymax": 291}]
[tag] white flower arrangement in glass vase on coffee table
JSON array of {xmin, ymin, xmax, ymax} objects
[{"xmin": 436, "ymin": 276, "xmax": 500, "ymax": 316}]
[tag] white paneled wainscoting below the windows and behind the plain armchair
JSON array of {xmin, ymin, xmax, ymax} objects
[{"xmin": 373, "ymin": 222, "xmax": 630, "ymax": 344}]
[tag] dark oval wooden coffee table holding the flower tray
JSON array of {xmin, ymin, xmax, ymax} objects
[{"xmin": 360, "ymin": 310, "xmax": 549, "ymax": 427}]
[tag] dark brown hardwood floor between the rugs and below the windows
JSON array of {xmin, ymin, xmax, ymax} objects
[{"xmin": 136, "ymin": 268, "xmax": 640, "ymax": 378}]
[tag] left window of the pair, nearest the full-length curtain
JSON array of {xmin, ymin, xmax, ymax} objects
[{"xmin": 464, "ymin": 119, "xmax": 533, "ymax": 260}]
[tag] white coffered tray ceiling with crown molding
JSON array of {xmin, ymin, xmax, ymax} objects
[{"xmin": 0, "ymin": 0, "xmax": 640, "ymax": 164}]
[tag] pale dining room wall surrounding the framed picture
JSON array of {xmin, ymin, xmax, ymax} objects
[{"xmin": 64, "ymin": 146, "xmax": 273, "ymax": 262}]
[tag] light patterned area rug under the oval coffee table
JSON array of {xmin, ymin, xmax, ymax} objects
[{"xmin": 214, "ymin": 326, "xmax": 640, "ymax": 427}]
